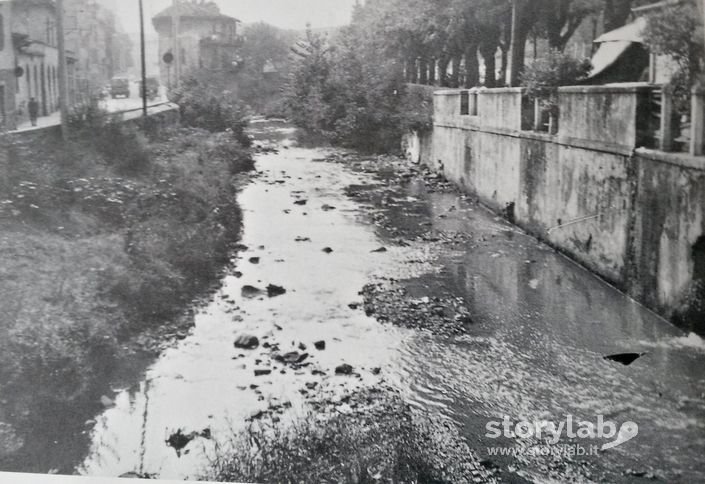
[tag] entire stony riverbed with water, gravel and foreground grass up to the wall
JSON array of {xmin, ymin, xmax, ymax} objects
[{"xmin": 2, "ymin": 122, "xmax": 705, "ymax": 482}]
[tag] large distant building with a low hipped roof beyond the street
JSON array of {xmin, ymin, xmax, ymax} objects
[{"xmin": 152, "ymin": 0, "xmax": 241, "ymax": 86}]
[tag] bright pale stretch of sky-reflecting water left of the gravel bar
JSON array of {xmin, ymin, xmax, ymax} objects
[{"xmin": 79, "ymin": 142, "xmax": 406, "ymax": 478}]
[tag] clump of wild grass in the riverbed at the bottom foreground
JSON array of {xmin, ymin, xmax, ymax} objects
[{"xmin": 205, "ymin": 391, "xmax": 486, "ymax": 484}]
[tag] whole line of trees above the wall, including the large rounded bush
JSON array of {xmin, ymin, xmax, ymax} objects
[{"xmin": 285, "ymin": 0, "xmax": 702, "ymax": 151}]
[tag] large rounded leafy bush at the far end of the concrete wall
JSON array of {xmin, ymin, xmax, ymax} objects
[{"xmin": 285, "ymin": 24, "xmax": 432, "ymax": 152}]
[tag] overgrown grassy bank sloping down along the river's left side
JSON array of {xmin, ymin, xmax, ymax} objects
[{"xmin": 0, "ymin": 124, "xmax": 253, "ymax": 442}]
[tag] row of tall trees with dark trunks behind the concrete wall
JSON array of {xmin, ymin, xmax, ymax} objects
[{"xmin": 353, "ymin": 0, "xmax": 650, "ymax": 87}]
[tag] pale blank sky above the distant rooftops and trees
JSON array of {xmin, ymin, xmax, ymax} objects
[{"xmin": 98, "ymin": 0, "xmax": 355, "ymax": 34}]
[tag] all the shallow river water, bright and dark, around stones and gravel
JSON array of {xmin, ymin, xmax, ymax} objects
[{"xmin": 3, "ymin": 123, "xmax": 705, "ymax": 482}]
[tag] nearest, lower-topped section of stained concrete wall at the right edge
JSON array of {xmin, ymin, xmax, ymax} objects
[{"xmin": 628, "ymin": 149, "xmax": 705, "ymax": 324}]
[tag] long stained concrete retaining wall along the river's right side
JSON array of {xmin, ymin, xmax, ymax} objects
[{"xmin": 425, "ymin": 85, "xmax": 705, "ymax": 329}]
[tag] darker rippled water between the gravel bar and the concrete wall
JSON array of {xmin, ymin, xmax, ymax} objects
[{"xmin": 382, "ymin": 187, "xmax": 705, "ymax": 482}]
